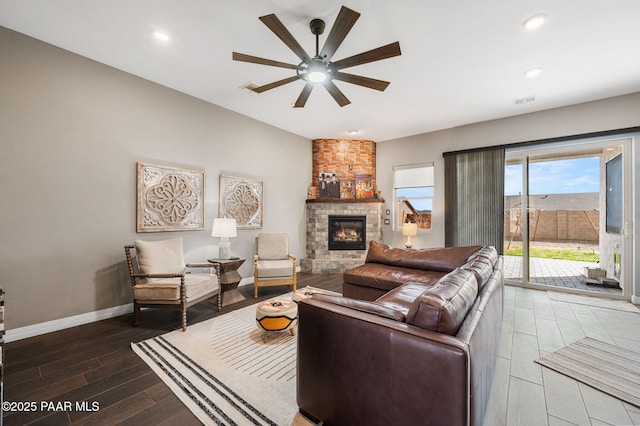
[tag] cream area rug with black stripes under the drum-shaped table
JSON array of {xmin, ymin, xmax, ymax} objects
[{"xmin": 131, "ymin": 295, "xmax": 312, "ymax": 426}]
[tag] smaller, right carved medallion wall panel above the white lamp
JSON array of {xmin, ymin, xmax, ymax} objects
[{"xmin": 219, "ymin": 175, "xmax": 263, "ymax": 229}]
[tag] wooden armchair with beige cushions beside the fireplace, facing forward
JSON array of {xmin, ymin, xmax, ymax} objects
[{"xmin": 253, "ymin": 234, "xmax": 298, "ymax": 299}]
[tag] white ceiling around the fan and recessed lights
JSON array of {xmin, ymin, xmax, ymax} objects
[{"xmin": 0, "ymin": 0, "xmax": 640, "ymax": 142}]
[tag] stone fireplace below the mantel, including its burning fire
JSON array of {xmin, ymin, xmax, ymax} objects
[{"xmin": 300, "ymin": 199, "xmax": 384, "ymax": 274}]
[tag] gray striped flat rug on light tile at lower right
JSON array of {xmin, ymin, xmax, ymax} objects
[{"xmin": 536, "ymin": 337, "xmax": 640, "ymax": 407}]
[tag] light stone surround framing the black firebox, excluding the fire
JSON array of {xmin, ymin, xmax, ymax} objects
[{"xmin": 300, "ymin": 200, "xmax": 383, "ymax": 274}]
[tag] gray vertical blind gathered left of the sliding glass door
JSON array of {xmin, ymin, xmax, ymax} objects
[{"xmin": 444, "ymin": 148, "xmax": 505, "ymax": 254}]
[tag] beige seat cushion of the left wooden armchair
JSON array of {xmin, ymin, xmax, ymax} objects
[{"xmin": 133, "ymin": 274, "xmax": 218, "ymax": 303}]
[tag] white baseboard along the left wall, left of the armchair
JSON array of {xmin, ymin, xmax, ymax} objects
[{"xmin": 4, "ymin": 303, "xmax": 133, "ymax": 342}]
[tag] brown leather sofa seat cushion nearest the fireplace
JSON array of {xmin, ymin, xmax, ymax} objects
[{"xmin": 343, "ymin": 263, "xmax": 446, "ymax": 291}]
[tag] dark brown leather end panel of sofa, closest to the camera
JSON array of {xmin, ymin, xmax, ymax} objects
[{"xmin": 297, "ymin": 296, "xmax": 470, "ymax": 425}]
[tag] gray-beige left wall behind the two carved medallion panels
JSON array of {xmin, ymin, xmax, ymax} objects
[{"xmin": 0, "ymin": 27, "xmax": 312, "ymax": 334}]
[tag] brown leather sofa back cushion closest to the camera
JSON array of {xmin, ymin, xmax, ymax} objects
[{"xmin": 406, "ymin": 269, "xmax": 478, "ymax": 335}]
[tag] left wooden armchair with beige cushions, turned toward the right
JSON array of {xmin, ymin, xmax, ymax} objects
[{"xmin": 124, "ymin": 238, "xmax": 222, "ymax": 331}]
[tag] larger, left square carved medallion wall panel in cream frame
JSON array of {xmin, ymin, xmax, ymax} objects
[{"xmin": 136, "ymin": 163, "xmax": 205, "ymax": 232}]
